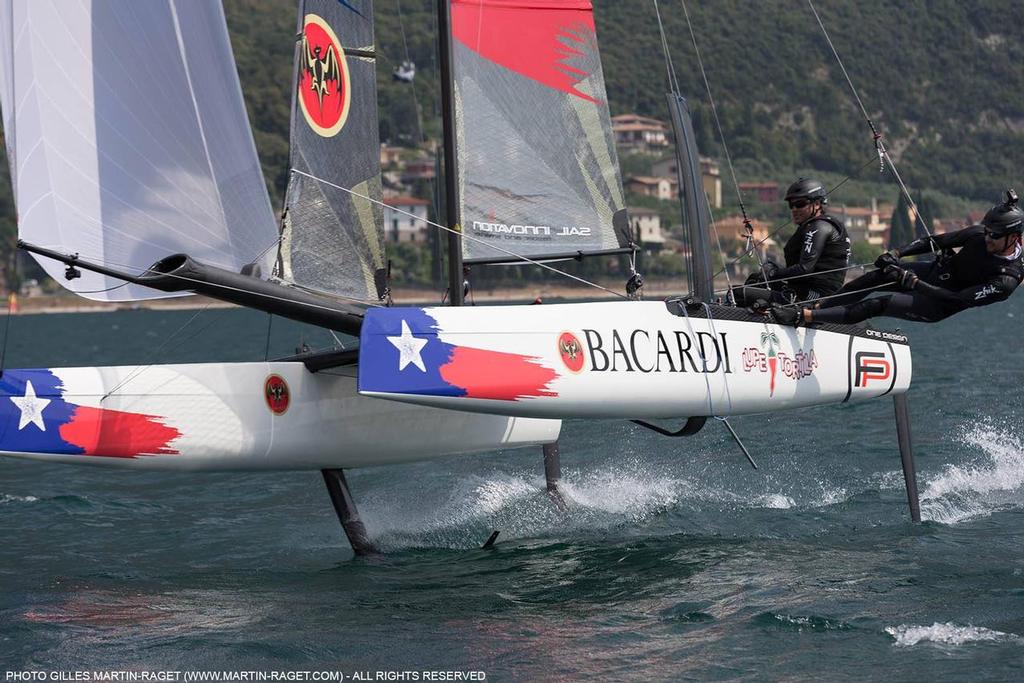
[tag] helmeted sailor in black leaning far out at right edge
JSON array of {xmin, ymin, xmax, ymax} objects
[{"xmin": 772, "ymin": 189, "xmax": 1024, "ymax": 325}]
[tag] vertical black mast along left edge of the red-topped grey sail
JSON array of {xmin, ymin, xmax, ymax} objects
[{"xmin": 437, "ymin": 0, "xmax": 463, "ymax": 306}]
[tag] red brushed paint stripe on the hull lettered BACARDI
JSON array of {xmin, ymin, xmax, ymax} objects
[{"xmin": 438, "ymin": 346, "xmax": 558, "ymax": 400}]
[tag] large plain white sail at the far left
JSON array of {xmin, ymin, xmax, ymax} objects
[{"xmin": 0, "ymin": 0, "xmax": 278, "ymax": 301}]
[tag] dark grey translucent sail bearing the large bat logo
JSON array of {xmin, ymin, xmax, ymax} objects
[{"xmin": 278, "ymin": 0, "xmax": 385, "ymax": 300}]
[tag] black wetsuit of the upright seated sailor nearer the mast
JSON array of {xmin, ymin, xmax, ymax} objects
[{"xmin": 733, "ymin": 214, "xmax": 850, "ymax": 306}]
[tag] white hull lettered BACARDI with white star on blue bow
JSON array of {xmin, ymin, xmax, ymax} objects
[{"xmin": 359, "ymin": 302, "xmax": 911, "ymax": 418}]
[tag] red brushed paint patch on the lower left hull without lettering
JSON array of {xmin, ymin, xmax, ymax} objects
[{"xmin": 60, "ymin": 405, "xmax": 181, "ymax": 458}]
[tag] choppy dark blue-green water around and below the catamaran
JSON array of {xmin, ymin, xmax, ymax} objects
[{"xmin": 0, "ymin": 295, "xmax": 1024, "ymax": 681}]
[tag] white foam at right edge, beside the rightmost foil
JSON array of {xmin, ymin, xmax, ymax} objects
[{"xmin": 921, "ymin": 423, "xmax": 1024, "ymax": 524}]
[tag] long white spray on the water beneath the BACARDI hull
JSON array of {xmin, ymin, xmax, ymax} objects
[{"xmin": 360, "ymin": 458, "xmax": 848, "ymax": 548}]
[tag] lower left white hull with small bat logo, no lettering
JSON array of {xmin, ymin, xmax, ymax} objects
[{"xmin": 0, "ymin": 362, "xmax": 561, "ymax": 471}]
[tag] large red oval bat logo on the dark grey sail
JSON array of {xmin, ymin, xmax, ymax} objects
[{"xmin": 296, "ymin": 14, "xmax": 351, "ymax": 137}]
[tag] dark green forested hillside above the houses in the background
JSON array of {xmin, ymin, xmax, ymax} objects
[{"xmin": 225, "ymin": 0, "xmax": 1024, "ymax": 208}]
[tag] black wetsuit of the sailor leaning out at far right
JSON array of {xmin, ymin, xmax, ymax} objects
[{"xmin": 813, "ymin": 225, "xmax": 1024, "ymax": 323}]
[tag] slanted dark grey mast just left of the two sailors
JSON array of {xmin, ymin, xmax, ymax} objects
[{"xmin": 667, "ymin": 92, "xmax": 715, "ymax": 301}]
